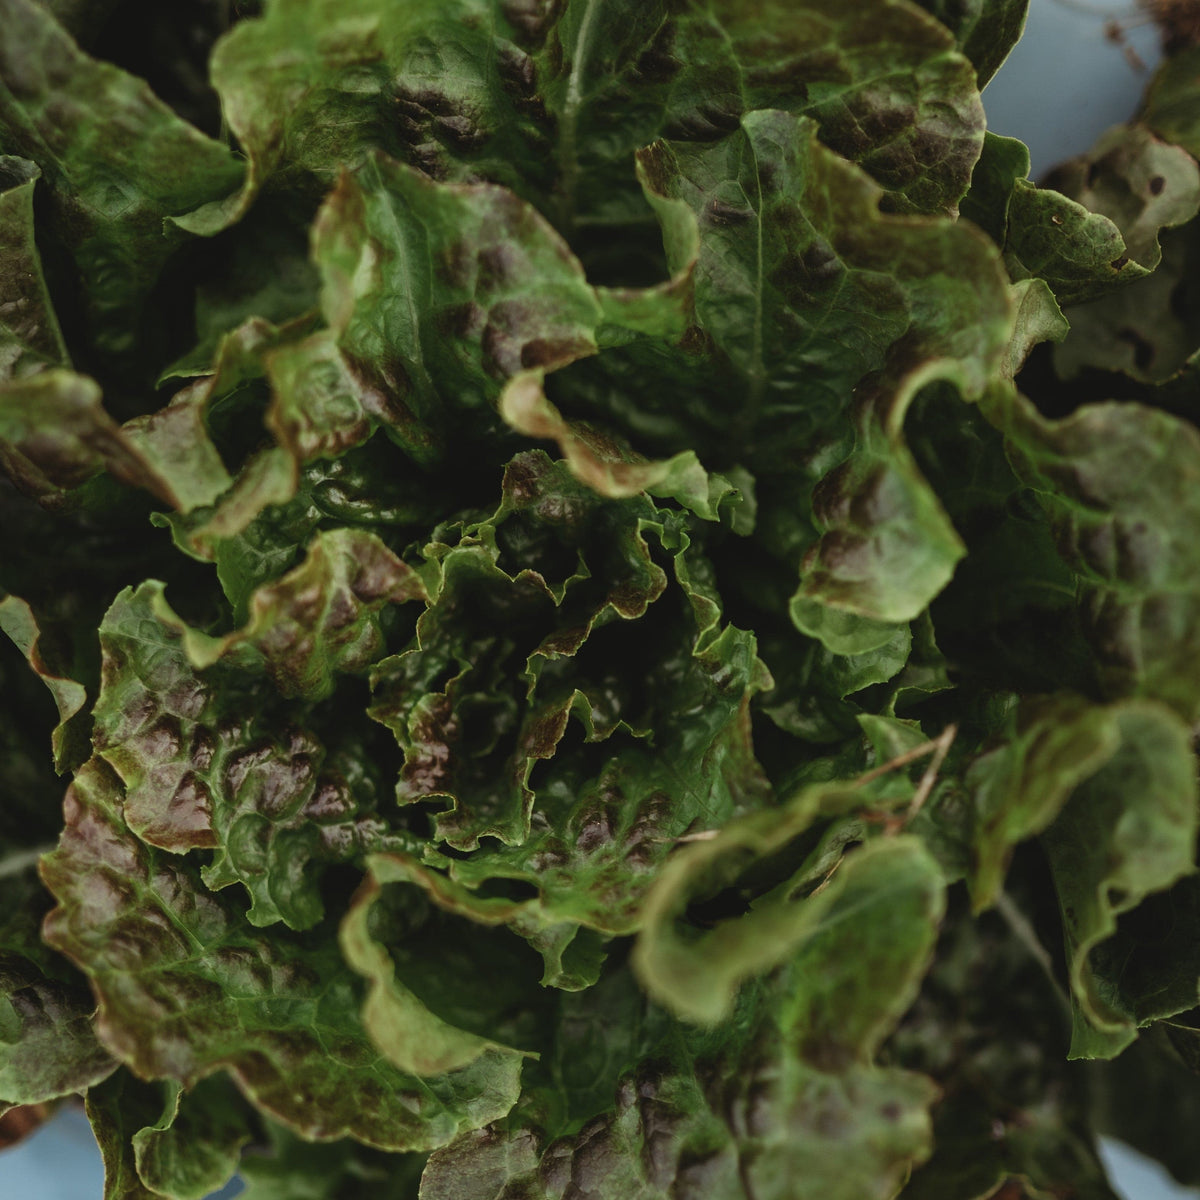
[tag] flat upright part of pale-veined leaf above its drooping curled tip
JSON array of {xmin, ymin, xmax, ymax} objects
[{"xmin": 638, "ymin": 112, "xmax": 1010, "ymax": 455}]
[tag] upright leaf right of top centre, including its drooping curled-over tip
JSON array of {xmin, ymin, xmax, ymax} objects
[{"xmin": 624, "ymin": 112, "xmax": 1012, "ymax": 636}]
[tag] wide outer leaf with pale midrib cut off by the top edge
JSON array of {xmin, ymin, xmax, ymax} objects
[{"xmin": 206, "ymin": 0, "xmax": 983, "ymax": 232}]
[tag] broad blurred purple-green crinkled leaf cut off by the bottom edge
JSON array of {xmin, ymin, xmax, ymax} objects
[{"xmin": 422, "ymin": 825, "xmax": 941, "ymax": 1200}]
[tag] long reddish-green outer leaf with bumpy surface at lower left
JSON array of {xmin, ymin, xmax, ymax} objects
[{"xmin": 43, "ymin": 760, "xmax": 518, "ymax": 1150}]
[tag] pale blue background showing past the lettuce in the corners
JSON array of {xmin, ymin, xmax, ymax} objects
[{"xmin": 0, "ymin": 0, "xmax": 1200, "ymax": 1200}]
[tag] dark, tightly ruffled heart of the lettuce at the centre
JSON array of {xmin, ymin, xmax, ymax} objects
[{"xmin": 372, "ymin": 454, "xmax": 768, "ymax": 966}]
